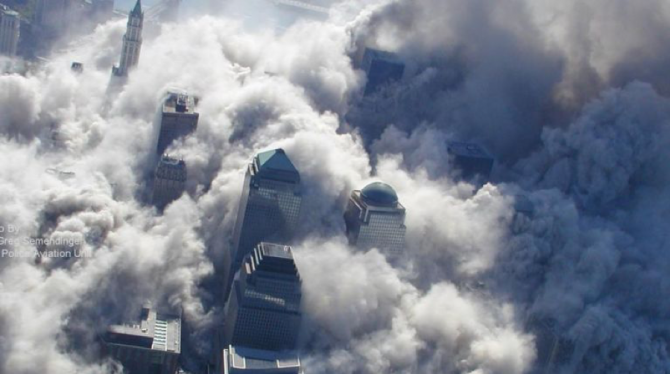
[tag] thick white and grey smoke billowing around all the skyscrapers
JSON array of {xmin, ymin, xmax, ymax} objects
[{"xmin": 0, "ymin": 0, "xmax": 670, "ymax": 374}]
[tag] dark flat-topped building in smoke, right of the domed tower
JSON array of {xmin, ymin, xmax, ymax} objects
[{"xmin": 447, "ymin": 142, "xmax": 495, "ymax": 183}]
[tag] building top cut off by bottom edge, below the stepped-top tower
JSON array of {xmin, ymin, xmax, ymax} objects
[{"xmin": 217, "ymin": 345, "xmax": 303, "ymax": 374}]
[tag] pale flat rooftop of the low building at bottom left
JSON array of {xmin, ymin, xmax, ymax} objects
[{"xmin": 104, "ymin": 307, "xmax": 181, "ymax": 354}]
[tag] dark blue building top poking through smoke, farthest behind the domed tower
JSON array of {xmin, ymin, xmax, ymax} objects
[{"xmin": 362, "ymin": 48, "xmax": 405, "ymax": 96}]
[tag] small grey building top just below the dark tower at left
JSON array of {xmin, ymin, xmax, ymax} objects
[{"xmin": 151, "ymin": 155, "xmax": 187, "ymax": 209}]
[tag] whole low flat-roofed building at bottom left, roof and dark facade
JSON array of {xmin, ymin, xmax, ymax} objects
[{"xmin": 102, "ymin": 307, "xmax": 181, "ymax": 374}]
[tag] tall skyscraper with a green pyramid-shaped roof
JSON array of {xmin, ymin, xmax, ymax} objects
[{"xmin": 224, "ymin": 149, "xmax": 302, "ymax": 293}]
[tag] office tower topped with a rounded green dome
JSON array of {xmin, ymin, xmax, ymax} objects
[{"xmin": 344, "ymin": 182, "xmax": 406, "ymax": 257}]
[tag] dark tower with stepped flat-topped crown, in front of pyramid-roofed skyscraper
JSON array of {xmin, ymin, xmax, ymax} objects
[{"xmin": 223, "ymin": 242, "xmax": 302, "ymax": 351}]
